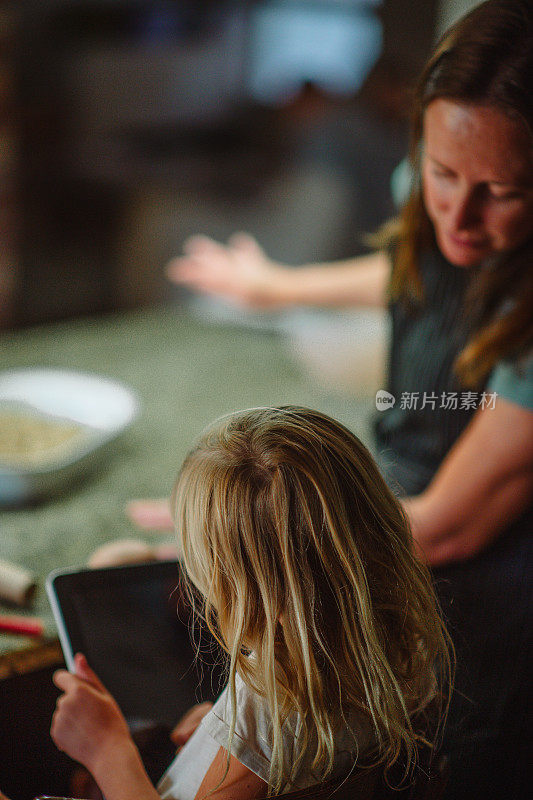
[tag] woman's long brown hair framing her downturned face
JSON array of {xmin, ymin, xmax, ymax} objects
[{"xmin": 390, "ymin": 0, "xmax": 533, "ymax": 387}]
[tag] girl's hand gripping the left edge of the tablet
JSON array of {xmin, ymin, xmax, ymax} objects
[{"xmin": 50, "ymin": 653, "xmax": 135, "ymax": 775}]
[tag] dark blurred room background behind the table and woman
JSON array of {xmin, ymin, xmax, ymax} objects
[{"xmin": 0, "ymin": 0, "xmax": 475, "ymax": 328}]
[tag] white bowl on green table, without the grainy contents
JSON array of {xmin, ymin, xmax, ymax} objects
[{"xmin": 0, "ymin": 369, "xmax": 139, "ymax": 505}]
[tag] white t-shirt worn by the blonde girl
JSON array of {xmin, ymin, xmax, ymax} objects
[{"xmin": 157, "ymin": 676, "xmax": 373, "ymax": 800}]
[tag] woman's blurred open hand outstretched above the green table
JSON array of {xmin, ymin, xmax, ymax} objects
[{"xmin": 167, "ymin": 233, "xmax": 288, "ymax": 309}]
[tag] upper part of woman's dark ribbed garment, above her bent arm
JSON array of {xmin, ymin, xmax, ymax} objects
[{"xmin": 375, "ymin": 250, "xmax": 478, "ymax": 494}]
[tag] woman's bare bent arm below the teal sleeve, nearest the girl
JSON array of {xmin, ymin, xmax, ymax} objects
[{"xmin": 404, "ymin": 398, "xmax": 533, "ymax": 566}]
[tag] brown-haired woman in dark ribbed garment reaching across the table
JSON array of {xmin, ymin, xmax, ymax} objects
[{"xmin": 131, "ymin": 0, "xmax": 533, "ymax": 799}]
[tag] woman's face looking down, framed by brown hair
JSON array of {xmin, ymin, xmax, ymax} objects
[{"xmin": 422, "ymin": 98, "xmax": 533, "ymax": 267}]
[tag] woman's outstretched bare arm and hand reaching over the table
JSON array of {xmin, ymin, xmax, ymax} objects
[{"xmin": 167, "ymin": 234, "xmax": 391, "ymax": 309}]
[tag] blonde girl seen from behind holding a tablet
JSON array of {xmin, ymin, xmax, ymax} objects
[{"xmin": 48, "ymin": 406, "xmax": 450, "ymax": 800}]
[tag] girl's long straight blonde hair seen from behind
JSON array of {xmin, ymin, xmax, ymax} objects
[{"xmin": 173, "ymin": 406, "xmax": 450, "ymax": 792}]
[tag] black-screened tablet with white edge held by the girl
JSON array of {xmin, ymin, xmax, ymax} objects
[{"xmin": 46, "ymin": 561, "xmax": 227, "ymax": 728}]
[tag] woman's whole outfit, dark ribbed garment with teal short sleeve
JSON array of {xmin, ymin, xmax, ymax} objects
[{"xmin": 376, "ymin": 252, "xmax": 533, "ymax": 800}]
